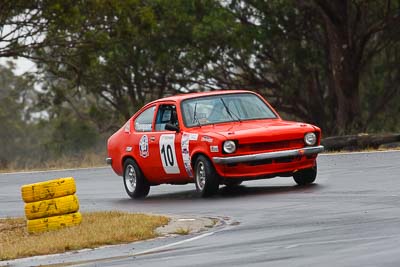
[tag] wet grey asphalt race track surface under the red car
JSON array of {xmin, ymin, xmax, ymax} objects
[{"xmin": 0, "ymin": 152, "xmax": 400, "ymax": 267}]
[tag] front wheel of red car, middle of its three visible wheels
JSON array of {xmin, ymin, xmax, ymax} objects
[{"xmin": 194, "ymin": 155, "xmax": 219, "ymax": 197}]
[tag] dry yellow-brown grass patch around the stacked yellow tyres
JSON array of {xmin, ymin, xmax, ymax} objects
[{"xmin": 0, "ymin": 211, "xmax": 169, "ymax": 260}]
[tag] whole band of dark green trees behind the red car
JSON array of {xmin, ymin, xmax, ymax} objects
[{"xmin": 0, "ymin": 0, "xmax": 400, "ymax": 168}]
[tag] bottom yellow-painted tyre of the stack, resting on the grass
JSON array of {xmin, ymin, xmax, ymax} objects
[{"xmin": 27, "ymin": 212, "xmax": 82, "ymax": 233}]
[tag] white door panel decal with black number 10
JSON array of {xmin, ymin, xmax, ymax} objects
[{"xmin": 160, "ymin": 134, "xmax": 180, "ymax": 174}]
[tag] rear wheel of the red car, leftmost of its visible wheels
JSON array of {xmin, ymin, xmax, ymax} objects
[{"xmin": 122, "ymin": 159, "xmax": 150, "ymax": 199}]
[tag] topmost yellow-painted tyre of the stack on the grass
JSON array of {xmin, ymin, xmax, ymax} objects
[{"xmin": 21, "ymin": 177, "xmax": 76, "ymax": 203}]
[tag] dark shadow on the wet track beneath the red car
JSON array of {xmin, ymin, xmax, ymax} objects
[{"xmin": 116, "ymin": 184, "xmax": 322, "ymax": 203}]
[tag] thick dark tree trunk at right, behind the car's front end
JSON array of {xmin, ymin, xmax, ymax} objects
[{"xmin": 321, "ymin": 0, "xmax": 362, "ymax": 134}]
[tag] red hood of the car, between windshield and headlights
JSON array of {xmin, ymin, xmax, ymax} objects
[{"xmin": 202, "ymin": 120, "xmax": 316, "ymax": 144}]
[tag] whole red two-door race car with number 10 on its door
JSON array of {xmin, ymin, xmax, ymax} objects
[{"xmin": 106, "ymin": 90, "xmax": 323, "ymax": 198}]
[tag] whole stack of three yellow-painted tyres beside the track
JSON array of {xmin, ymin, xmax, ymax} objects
[{"xmin": 21, "ymin": 177, "xmax": 82, "ymax": 233}]
